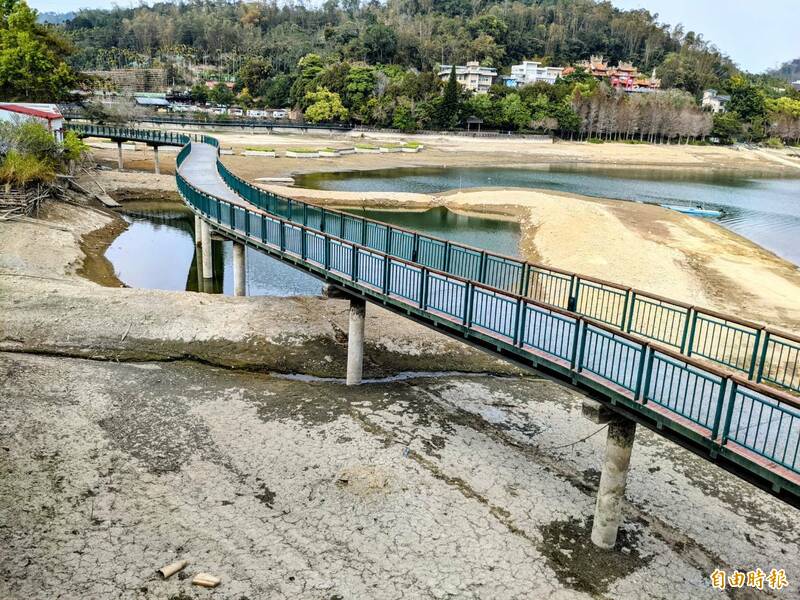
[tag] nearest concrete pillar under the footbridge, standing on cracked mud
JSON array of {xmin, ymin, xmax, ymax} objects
[{"xmin": 592, "ymin": 417, "xmax": 636, "ymax": 550}]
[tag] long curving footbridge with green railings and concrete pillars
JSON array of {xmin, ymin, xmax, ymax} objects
[{"xmin": 70, "ymin": 125, "xmax": 800, "ymax": 548}]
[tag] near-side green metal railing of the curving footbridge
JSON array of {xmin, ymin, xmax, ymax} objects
[{"xmin": 177, "ymin": 159, "xmax": 800, "ymax": 498}]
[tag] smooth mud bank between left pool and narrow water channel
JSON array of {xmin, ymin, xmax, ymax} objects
[{"xmin": 0, "ymin": 204, "xmax": 517, "ymax": 377}]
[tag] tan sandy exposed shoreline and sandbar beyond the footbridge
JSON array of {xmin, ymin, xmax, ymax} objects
[{"xmin": 84, "ymin": 135, "xmax": 800, "ymax": 332}]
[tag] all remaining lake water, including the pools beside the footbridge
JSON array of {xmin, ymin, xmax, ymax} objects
[{"xmin": 106, "ymin": 168, "xmax": 800, "ymax": 296}]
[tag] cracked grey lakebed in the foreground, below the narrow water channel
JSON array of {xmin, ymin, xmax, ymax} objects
[{"xmin": 0, "ymin": 353, "xmax": 800, "ymax": 600}]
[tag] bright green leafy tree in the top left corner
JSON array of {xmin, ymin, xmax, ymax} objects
[{"xmin": 0, "ymin": 0, "xmax": 79, "ymax": 102}]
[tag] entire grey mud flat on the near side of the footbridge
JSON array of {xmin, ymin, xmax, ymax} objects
[{"xmin": 0, "ymin": 190, "xmax": 800, "ymax": 600}]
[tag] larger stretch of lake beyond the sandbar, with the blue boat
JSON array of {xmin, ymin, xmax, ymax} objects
[{"xmin": 295, "ymin": 168, "xmax": 800, "ymax": 264}]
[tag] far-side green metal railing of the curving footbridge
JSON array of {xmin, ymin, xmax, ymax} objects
[{"xmin": 212, "ymin": 148, "xmax": 800, "ymax": 392}]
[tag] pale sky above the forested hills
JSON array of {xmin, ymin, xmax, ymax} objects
[{"xmin": 28, "ymin": 0, "xmax": 800, "ymax": 73}]
